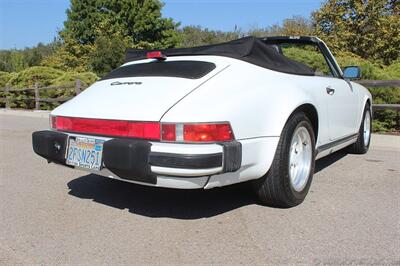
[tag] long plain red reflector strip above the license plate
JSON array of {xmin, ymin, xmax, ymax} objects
[{"xmin": 51, "ymin": 116, "xmax": 160, "ymax": 140}]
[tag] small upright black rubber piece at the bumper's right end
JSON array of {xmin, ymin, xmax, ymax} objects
[{"xmin": 220, "ymin": 141, "xmax": 242, "ymax": 173}]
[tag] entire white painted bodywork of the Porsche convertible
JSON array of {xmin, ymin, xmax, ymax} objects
[{"xmin": 44, "ymin": 43, "xmax": 371, "ymax": 189}]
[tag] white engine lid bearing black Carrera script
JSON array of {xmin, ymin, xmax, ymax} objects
[{"xmin": 52, "ymin": 57, "xmax": 227, "ymax": 121}]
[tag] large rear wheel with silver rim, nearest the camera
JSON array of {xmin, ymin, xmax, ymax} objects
[{"xmin": 253, "ymin": 112, "xmax": 315, "ymax": 208}]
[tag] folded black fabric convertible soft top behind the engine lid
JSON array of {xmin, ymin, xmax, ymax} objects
[{"xmin": 125, "ymin": 37, "xmax": 314, "ymax": 76}]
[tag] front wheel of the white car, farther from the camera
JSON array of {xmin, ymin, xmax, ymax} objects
[{"xmin": 347, "ymin": 103, "xmax": 372, "ymax": 154}]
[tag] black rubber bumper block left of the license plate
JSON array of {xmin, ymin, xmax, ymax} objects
[{"xmin": 32, "ymin": 130, "xmax": 68, "ymax": 164}]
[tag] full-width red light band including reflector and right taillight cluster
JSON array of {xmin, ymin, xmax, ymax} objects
[{"xmin": 50, "ymin": 116, "xmax": 234, "ymax": 143}]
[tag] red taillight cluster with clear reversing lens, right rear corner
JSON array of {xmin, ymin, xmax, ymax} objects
[{"xmin": 161, "ymin": 123, "xmax": 234, "ymax": 142}]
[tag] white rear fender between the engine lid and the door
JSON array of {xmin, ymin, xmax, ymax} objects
[{"xmin": 161, "ymin": 63, "xmax": 319, "ymax": 140}]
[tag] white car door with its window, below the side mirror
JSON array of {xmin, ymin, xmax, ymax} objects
[{"xmin": 280, "ymin": 39, "xmax": 358, "ymax": 142}]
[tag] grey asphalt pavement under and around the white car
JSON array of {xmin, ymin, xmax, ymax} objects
[{"xmin": 0, "ymin": 113, "xmax": 400, "ymax": 265}]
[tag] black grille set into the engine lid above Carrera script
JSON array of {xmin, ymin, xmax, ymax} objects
[{"xmin": 103, "ymin": 61, "xmax": 216, "ymax": 80}]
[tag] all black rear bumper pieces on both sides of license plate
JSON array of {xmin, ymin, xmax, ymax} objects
[{"xmin": 32, "ymin": 130, "xmax": 242, "ymax": 184}]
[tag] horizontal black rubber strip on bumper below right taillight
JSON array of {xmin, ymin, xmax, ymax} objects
[{"xmin": 149, "ymin": 152, "xmax": 222, "ymax": 169}]
